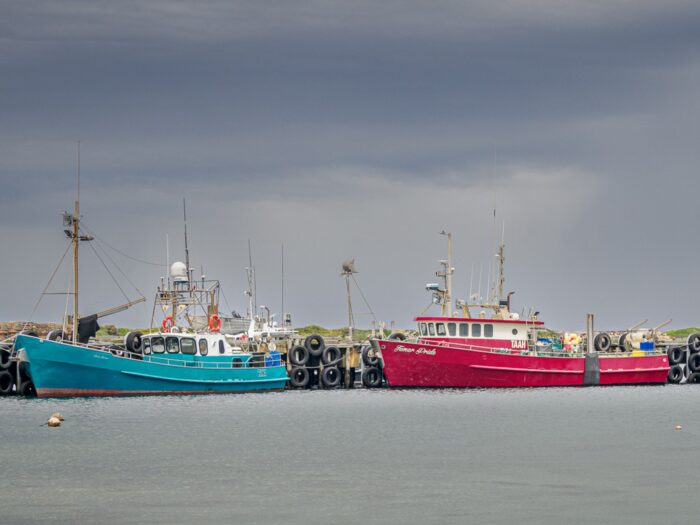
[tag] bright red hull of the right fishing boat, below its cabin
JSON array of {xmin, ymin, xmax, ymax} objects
[{"xmin": 376, "ymin": 340, "xmax": 669, "ymax": 388}]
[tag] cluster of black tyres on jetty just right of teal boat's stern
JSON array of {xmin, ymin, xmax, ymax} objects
[{"xmin": 287, "ymin": 334, "xmax": 342, "ymax": 389}]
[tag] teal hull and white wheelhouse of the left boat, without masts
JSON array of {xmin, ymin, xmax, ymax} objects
[{"xmin": 15, "ymin": 333, "xmax": 287, "ymax": 397}]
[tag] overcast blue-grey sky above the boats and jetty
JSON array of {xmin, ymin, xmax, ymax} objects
[{"xmin": 0, "ymin": 1, "xmax": 700, "ymax": 329}]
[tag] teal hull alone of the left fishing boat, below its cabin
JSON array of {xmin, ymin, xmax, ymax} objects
[{"xmin": 15, "ymin": 335, "xmax": 287, "ymax": 397}]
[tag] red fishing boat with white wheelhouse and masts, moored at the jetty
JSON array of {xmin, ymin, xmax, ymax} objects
[{"xmin": 372, "ymin": 234, "xmax": 669, "ymax": 388}]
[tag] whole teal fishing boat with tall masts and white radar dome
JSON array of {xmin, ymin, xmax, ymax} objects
[{"xmin": 14, "ymin": 158, "xmax": 287, "ymax": 397}]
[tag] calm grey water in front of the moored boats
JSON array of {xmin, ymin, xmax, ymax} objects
[{"xmin": 0, "ymin": 386, "xmax": 700, "ymax": 524}]
